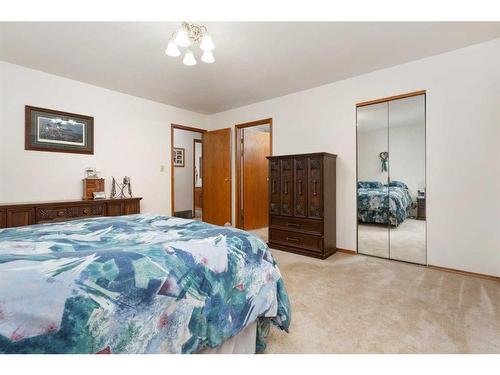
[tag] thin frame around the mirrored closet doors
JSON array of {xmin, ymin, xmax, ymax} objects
[{"xmin": 354, "ymin": 90, "xmax": 429, "ymax": 265}]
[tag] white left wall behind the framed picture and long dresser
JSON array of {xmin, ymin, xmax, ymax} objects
[{"xmin": 0, "ymin": 62, "xmax": 208, "ymax": 214}]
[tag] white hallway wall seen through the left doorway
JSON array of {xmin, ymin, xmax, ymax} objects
[{"xmin": 174, "ymin": 129, "xmax": 201, "ymax": 212}]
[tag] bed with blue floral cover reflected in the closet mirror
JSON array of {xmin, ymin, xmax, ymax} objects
[{"xmin": 358, "ymin": 181, "xmax": 412, "ymax": 226}]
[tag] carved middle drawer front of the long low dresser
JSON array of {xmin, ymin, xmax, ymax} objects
[{"xmin": 36, "ymin": 203, "xmax": 106, "ymax": 223}]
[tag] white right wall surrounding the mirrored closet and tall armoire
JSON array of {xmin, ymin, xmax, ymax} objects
[{"xmin": 210, "ymin": 39, "xmax": 500, "ymax": 276}]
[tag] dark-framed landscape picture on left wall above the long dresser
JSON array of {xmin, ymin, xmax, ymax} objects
[{"xmin": 24, "ymin": 105, "xmax": 94, "ymax": 154}]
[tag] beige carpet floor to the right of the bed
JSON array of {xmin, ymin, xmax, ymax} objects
[{"xmin": 249, "ymin": 229, "xmax": 500, "ymax": 353}]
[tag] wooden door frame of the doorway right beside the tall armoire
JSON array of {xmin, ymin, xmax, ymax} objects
[{"xmin": 234, "ymin": 118, "xmax": 273, "ymax": 229}]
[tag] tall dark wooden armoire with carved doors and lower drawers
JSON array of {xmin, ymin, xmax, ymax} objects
[{"xmin": 268, "ymin": 152, "xmax": 337, "ymax": 259}]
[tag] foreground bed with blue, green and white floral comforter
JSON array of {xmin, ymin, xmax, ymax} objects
[{"xmin": 0, "ymin": 215, "xmax": 291, "ymax": 353}]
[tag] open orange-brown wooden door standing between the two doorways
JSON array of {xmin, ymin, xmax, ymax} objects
[{"xmin": 202, "ymin": 129, "xmax": 231, "ymax": 225}]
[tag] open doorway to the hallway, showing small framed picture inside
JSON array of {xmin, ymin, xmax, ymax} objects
[{"xmin": 170, "ymin": 124, "xmax": 206, "ymax": 220}]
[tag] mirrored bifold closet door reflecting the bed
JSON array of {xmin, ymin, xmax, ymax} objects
[{"xmin": 357, "ymin": 94, "xmax": 427, "ymax": 264}]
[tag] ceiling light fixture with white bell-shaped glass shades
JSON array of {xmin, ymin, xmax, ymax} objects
[{"xmin": 165, "ymin": 22, "xmax": 215, "ymax": 66}]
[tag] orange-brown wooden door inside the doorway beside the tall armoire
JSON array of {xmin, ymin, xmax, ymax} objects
[{"xmin": 240, "ymin": 128, "xmax": 271, "ymax": 230}]
